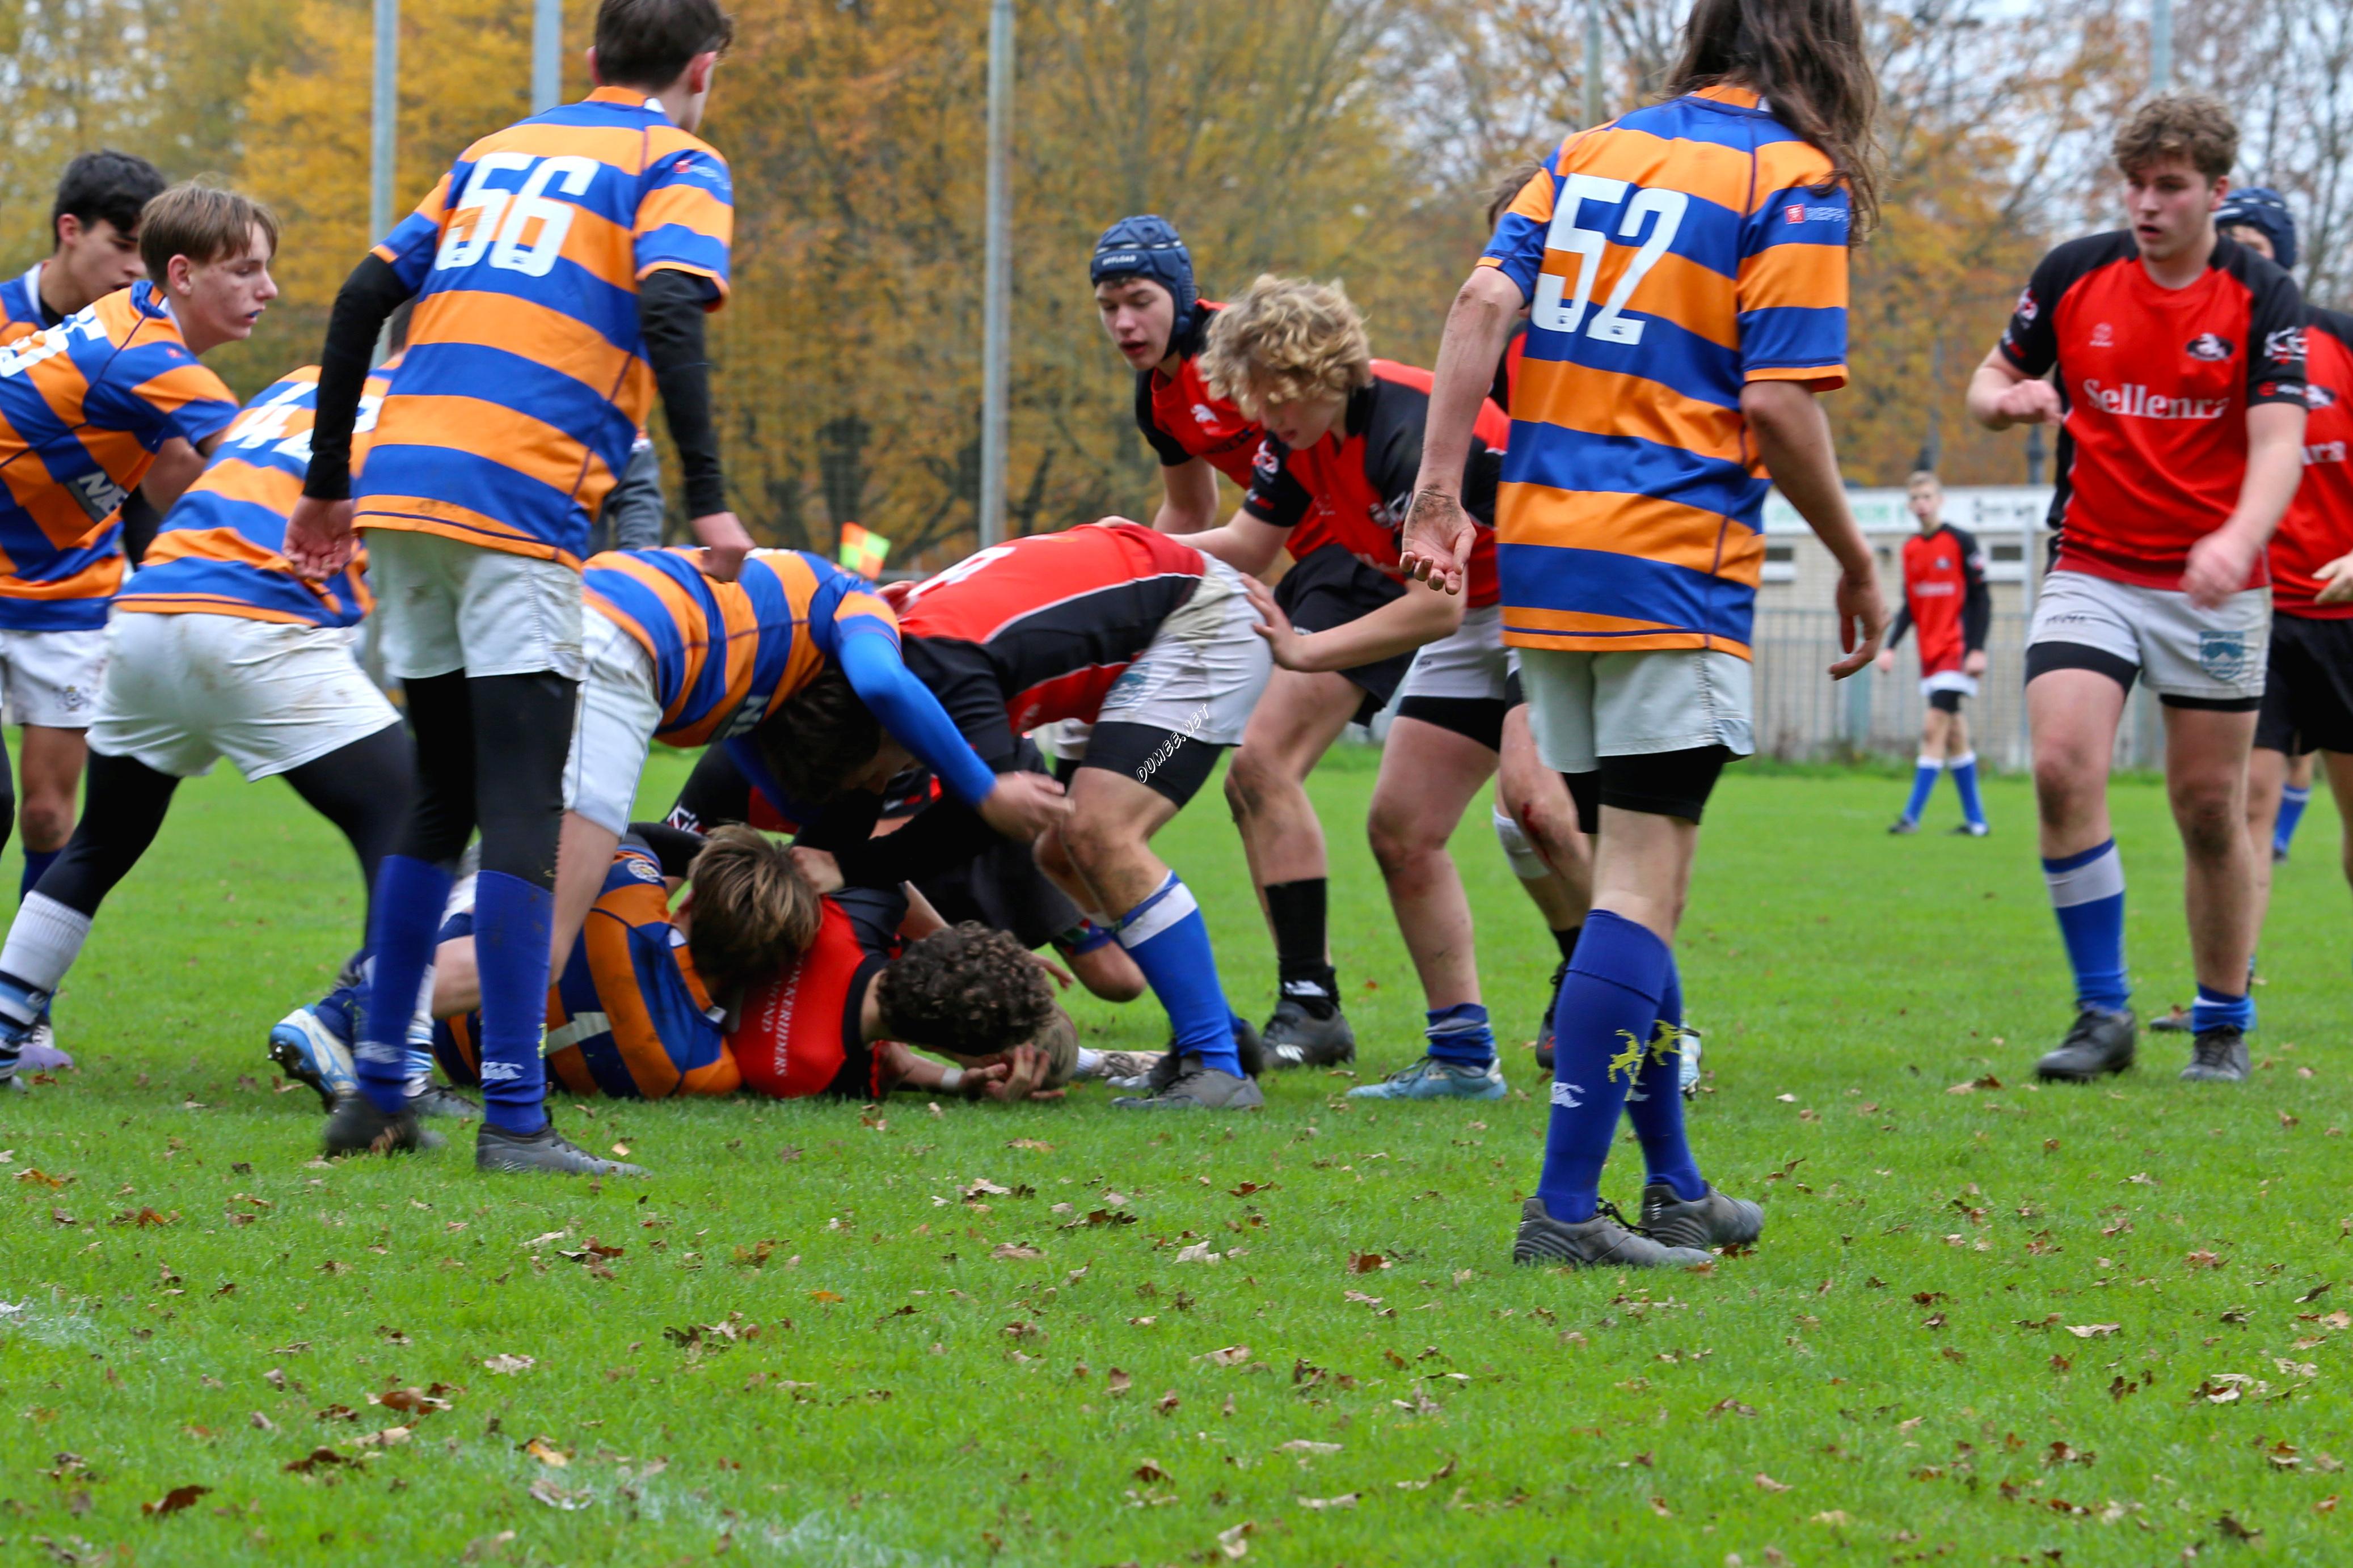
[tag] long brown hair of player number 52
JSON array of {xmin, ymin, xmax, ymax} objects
[{"xmin": 1666, "ymin": 0, "xmax": 1880, "ymax": 244}]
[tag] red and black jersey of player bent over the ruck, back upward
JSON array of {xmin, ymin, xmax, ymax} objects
[{"xmin": 899, "ymin": 522, "xmax": 1209, "ymax": 771}]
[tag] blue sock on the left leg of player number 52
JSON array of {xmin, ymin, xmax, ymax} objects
[{"xmin": 1537, "ymin": 910, "xmax": 1675, "ymax": 1225}]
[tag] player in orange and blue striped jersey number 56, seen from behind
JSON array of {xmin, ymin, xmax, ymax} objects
[{"xmin": 287, "ymin": 0, "xmax": 750, "ymax": 1176}]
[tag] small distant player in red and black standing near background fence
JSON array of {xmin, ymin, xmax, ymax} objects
[{"xmin": 1880, "ymin": 468, "xmax": 1993, "ymax": 839}]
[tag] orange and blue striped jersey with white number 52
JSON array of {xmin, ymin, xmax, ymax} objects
[{"xmin": 1480, "ymin": 87, "xmax": 1852, "ymax": 658}]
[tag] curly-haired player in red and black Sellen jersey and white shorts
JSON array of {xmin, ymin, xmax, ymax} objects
[{"xmin": 1970, "ymin": 94, "xmax": 2304, "ymax": 1081}]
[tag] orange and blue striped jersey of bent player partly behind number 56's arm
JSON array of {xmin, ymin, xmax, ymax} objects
[{"xmin": 115, "ymin": 360, "xmax": 398, "ymax": 625}]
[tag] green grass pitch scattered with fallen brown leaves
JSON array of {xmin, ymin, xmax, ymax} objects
[{"xmin": 0, "ymin": 755, "xmax": 2353, "ymax": 1568}]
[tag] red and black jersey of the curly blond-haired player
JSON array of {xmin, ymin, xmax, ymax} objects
[{"xmin": 1242, "ymin": 360, "xmax": 1511, "ymax": 609}]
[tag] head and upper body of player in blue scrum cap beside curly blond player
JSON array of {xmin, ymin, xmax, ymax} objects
[{"xmin": 1087, "ymin": 212, "xmax": 1266, "ymax": 534}]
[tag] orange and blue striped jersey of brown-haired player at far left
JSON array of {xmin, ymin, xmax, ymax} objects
[{"xmin": 0, "ymin": 282, "xmax": 238, "ymax": 632}]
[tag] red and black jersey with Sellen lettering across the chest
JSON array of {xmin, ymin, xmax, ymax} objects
[{"xmin": 2002, "ymin": 230, "xmax": 2304, "ymax": 588}]
